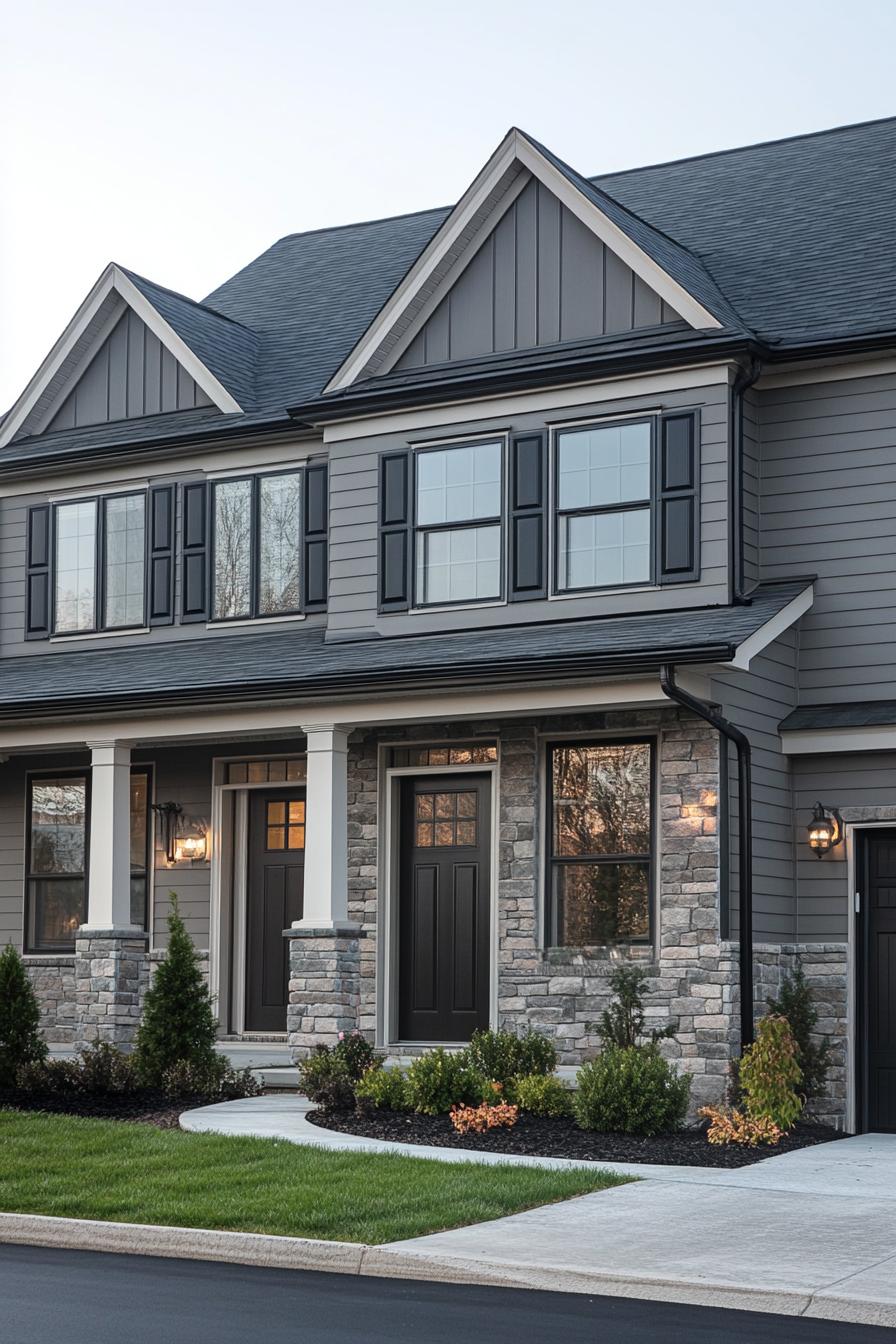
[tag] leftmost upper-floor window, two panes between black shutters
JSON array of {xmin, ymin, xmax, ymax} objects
[{"xmin": 54, "ymin": 493, "xmax": 146, "ymax": 634}]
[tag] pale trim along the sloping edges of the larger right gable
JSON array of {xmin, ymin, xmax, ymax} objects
[{"xmin": 325, "ymin": 129, "xmax": 721, "ymax": 392}]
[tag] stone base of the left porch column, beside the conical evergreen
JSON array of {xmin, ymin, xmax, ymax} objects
[{"xmin": 74, "ymin": 929, "xmax": 149, "ymax": 1050}]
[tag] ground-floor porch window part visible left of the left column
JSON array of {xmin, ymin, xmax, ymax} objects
[{"xmin": 26, "ymin": 774, "xmax": 89, "ymax": 952}]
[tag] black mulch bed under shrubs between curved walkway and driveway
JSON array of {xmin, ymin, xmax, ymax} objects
[{"xmin": 308, "ymin": 1110, "xmax": 845, "ymax": 1167}]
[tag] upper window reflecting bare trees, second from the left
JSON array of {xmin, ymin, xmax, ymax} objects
[{"xmin": 212, "ymin": 472, "xmax": 302, "ymax": 621}]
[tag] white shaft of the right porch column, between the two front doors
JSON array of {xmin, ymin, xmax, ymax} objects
[{"xmin": 294, "ymin": 724, "xmax": 348, "ymax": 930}]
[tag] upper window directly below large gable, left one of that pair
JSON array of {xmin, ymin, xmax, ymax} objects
[{"xmin": 414, "ymin": 439, "xmax": 504, "ymax": 606}]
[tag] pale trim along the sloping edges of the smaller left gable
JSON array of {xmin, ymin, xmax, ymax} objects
[{"xmin": 0, "ymin": 262, "xmax": 242, "ymax": 448}]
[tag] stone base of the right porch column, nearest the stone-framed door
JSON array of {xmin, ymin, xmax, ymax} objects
[{"xmin": 283, "ymin": 925, "xmax": 364, "ymax": 1059}]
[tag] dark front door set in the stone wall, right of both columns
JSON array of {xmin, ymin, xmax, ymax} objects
[{"xmin": 398, "ymin": 775, "xmax": 490, "ymax": 1042}]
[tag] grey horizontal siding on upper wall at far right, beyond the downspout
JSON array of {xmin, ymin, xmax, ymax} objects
[{"xmin": 758, "ymin": 374, "xmax": 896, "ymax": 704}]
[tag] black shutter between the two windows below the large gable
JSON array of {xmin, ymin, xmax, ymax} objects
[{"xmin": 508, "ymin": 433, "xmax": 548, "ymax": 602}]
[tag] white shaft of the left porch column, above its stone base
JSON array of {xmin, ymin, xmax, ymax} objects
[{"xmin": 82, "ymin": 742, "xmax": 134, "ymax": 931}]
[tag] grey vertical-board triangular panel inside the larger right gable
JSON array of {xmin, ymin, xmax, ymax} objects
[{"xmin": 394, "ymin": 177, "xmax": 681, "ymax": 370}]
